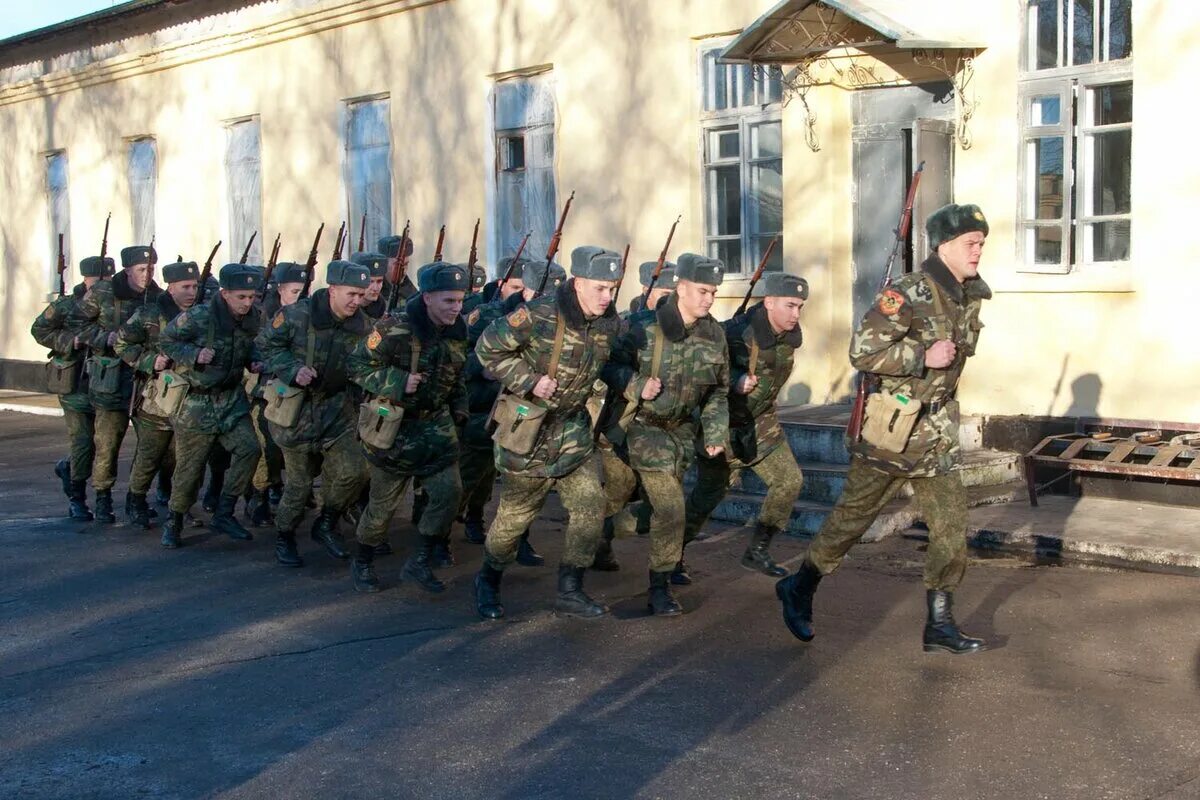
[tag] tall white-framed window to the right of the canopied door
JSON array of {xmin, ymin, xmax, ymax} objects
[{"xmin": 1018, "ymin": 0, "xmax": 1133, "ymax": 273}]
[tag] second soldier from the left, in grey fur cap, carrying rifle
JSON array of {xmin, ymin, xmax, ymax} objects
[{"xmin": 79, "ymin": 245, "xmax": 161, "ymax": 522}]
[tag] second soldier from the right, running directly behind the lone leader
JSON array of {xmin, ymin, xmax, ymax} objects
[{"xmin": 678, "ymin": 272, "xmax": 809, "ymax": 578}]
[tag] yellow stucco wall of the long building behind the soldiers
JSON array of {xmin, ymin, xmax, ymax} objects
[{"xmin": 0, "ymin": 0, "xmax": 1200, "ymax": 421}]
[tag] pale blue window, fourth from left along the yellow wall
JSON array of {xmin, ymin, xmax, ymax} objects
[{"xmin": 346, "ymin": 100, "xmax": 392, "ymax": 253}]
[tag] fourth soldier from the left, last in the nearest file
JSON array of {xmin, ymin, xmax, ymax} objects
[{"xmin": 160, "ymin": 264, "xmax": 263, "ymax": 548}]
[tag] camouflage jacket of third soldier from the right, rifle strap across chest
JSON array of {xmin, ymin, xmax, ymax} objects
[{"xmin": 605, "ymin": 295, "xmax": 730, "ymax": 475}]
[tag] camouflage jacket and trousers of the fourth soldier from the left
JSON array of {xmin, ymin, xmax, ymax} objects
[{"xmin": 160, "ymin": 293, "xmax": 260, "ymax": 513}]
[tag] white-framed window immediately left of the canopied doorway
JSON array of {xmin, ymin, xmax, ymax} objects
[{"xmin": 700, "ymin": 48, "xmax": 784, "ymax": 273}]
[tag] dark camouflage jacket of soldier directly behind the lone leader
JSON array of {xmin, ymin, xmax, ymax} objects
[{"xmin": 721, "ymin": 303, "xmax": 804, "ymax": 464}]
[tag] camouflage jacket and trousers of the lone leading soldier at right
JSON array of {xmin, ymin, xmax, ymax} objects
[{"xmin": 808, "ymin": 254, "xmax": 991, "ymax": 591}]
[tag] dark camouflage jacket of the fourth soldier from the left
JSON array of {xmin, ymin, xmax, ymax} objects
[{"xmin": 158, "ymin": 293, "xmax": 262, "ymax": 434}]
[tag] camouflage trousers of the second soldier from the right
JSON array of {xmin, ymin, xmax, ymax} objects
[{"xmin": 683, "ymin": 444, "xmax": 804, "ymax": 545}]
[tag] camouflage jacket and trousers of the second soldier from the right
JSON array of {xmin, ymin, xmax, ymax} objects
[{"xmin": 684, "ymin": 303, "xmax": 803, "ymax": 545}]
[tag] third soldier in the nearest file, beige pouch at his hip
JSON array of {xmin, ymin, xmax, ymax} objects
[{"xmin": 258, "ymin": 261, "xmax": 371, "ymax": 566}]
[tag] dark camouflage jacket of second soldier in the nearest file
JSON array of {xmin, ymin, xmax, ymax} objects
[{"xmin": 347, "ymin": 296, "xmax": 467, "ymax": 477}]
